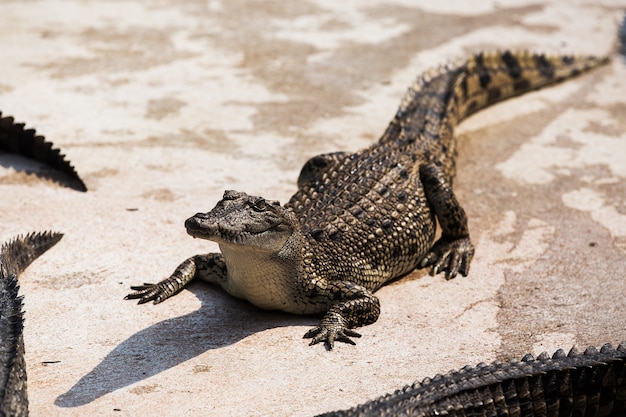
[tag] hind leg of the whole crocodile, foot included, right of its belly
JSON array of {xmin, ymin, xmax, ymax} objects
[{"xmin": 420, "ymin": 164, "xmax": 474, "ymax": 279}]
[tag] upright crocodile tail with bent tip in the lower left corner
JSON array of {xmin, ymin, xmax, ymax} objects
[{"xmin": 0, "ymin": 232, "xmax": 63, "ymax": 417}]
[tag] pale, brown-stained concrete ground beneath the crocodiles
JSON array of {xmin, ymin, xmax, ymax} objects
[{"xmin": 0, "ymin": 0, "xmax": 626, "ymax": 416}]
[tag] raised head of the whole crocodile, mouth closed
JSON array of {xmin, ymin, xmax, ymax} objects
[{"xmin": 185, "ymin": 190, "xmax": 297, "ymax": 252}]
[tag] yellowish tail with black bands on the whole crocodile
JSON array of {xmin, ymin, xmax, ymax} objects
[{"xmin": 380, "ymin": 51, "xmax": 608, "ymax": 180}]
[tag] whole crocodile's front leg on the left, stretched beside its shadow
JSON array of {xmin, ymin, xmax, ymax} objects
[{"xmin": 124, "ymin": 253, "xmax": 227, "ymax": 304}]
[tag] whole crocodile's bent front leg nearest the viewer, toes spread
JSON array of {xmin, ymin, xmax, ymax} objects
[{"xmin": 304, "ymin": 281, "xmax": 380, "ymax": 350}]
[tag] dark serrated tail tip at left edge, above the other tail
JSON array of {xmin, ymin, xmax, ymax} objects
[{"xmin": 0, "ymin": 112, "xmax": 87, "ymax": 191}]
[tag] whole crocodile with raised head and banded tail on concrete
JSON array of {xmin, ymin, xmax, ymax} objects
[{"xmin": 126, "ymin": 51, "xmax": 607, "ymax": 349}]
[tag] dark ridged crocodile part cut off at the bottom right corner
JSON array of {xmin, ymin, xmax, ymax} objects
[{"xmin": 319, "ymin": 344, "xmax": 626, "ymax": 417}]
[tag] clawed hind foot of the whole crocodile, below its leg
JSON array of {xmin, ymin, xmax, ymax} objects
[{"xmin": 420, "ymin": 237, "xmax": 474, "ymax": 279}]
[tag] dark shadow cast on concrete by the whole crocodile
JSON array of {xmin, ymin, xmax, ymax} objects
[{"xmin": 55, "ymin": 283, "xmax": 316, "ymax": 408}]
